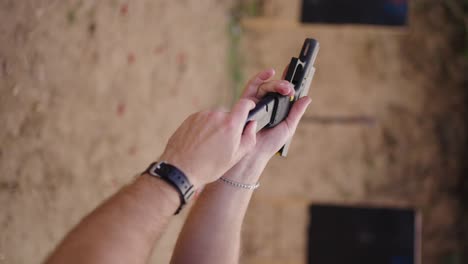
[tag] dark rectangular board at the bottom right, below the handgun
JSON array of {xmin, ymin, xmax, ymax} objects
[{"xmin": 308, "ymin": 205, "xmax": 420, "ymax": 264}]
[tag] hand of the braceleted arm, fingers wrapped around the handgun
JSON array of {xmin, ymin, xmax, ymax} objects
[{"xmin": 224, "ymin": 69, "xmax": 311, "ymax": 183}]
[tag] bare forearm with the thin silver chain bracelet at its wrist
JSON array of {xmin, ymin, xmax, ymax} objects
[{"xmin": 171, "ymin": 157, "xmax": 263, "ymax": 264}]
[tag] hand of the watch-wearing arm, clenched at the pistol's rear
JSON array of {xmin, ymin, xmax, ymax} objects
[{"xmin": 160, "ymin": 98, "xmax": 256, "ymax": 187}]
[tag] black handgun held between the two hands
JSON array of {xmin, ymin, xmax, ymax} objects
[{"xmin": 247, "ymin": 38, "xmax": 319, "ymax": 157}]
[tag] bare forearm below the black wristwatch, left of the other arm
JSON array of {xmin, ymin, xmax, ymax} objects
[{"xmin": 46, "ymin": 175, "xmax": 180, "ymax": 264}]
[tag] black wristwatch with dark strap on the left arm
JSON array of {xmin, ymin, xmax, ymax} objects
[{"xmin": 142, "ymin": 161, "xmax": 195, "ymax": 215}]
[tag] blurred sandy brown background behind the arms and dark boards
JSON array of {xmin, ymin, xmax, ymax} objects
[{"xmin": 0, "ymin": 0, "xmax": 468, "ymax": 264}]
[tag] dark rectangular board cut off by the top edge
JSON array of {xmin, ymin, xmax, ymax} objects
[{"xmin": 301, "ymin": 0, "xmax": 408, "ymax": 26}]
